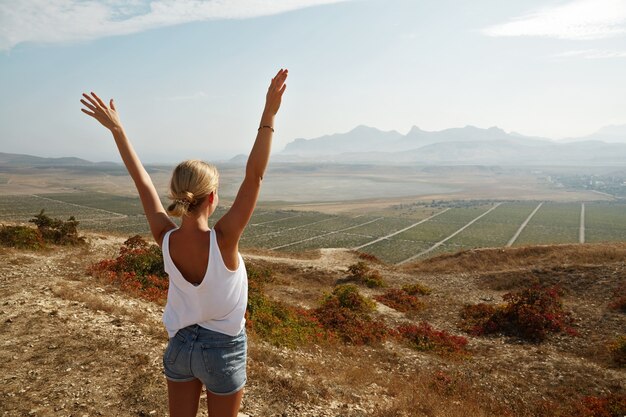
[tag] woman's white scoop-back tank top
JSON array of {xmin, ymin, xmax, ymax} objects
[{"xmin": 163, "ymin": 229, "xmax": 248, "ymax": 337}]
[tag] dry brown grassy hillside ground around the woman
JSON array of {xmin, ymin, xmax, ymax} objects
[{"xmin": 0, "ymin": 235, "xmax": 626, "ymax": 417}]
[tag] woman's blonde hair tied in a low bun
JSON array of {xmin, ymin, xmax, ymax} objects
[{"xmin": 167, "ymin": 159, "xmax": 219, "ymax": 217}]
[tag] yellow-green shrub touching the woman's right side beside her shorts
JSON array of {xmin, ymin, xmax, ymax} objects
[{"xmin": 246, "ymin": 265, "xmax": 331, "ymax": 348}]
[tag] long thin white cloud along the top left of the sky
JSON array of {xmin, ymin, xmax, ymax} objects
[{"xmin": 0, "ymin": 0, "xmax": 347, "ymax": 50}]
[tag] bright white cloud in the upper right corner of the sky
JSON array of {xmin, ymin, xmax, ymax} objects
[{"xmin": 482, "ymin": 0, "xmax": 626, "ymax": 40}]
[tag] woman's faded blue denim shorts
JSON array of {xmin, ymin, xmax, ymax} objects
[{"xmin": 163, "ymin": 324, "xmax": 248, "ymax": 395}]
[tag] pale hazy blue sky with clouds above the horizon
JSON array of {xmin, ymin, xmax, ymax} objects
[{"xmin": 0, "ymin": 0, "xmax": 626, "ymax": 162}]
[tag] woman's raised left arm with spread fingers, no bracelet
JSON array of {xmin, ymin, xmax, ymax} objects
[{"xmin": 80, "ymin": 93, "xmax": 176, "ymax": 246}]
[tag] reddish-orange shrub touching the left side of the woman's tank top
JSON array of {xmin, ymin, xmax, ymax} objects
[{"xmin": 88, "ymin": 235, "xmax": 169, "ymax": 302}]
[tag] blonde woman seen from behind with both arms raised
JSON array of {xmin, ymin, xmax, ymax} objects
[{"xmin": 80, "ymin": 69, "xmax": 287, "ymax": 417}]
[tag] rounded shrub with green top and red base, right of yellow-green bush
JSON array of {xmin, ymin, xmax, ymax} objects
[{"xmin": 313, "ymin": 285, "xmax": 389, "ymax": 345}]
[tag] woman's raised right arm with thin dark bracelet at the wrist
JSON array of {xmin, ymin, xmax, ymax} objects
[{"xmin": 215, "ymin": 69, "xmax": 287, "ymax": 250}]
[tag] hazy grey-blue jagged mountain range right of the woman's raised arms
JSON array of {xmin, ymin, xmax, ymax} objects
[{"xmin": 274, "ymin": 126, "xmax": 626, "ymax": 165}]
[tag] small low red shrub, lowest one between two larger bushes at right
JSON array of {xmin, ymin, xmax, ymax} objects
[{"xmin": 396, "ymin": 322, "xmax": 467, "ymax": 355}]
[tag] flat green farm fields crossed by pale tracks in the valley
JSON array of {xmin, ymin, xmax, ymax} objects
[{"xmin": 0, "ymin": 192, "xmax": 626, "ymax": 263}]
